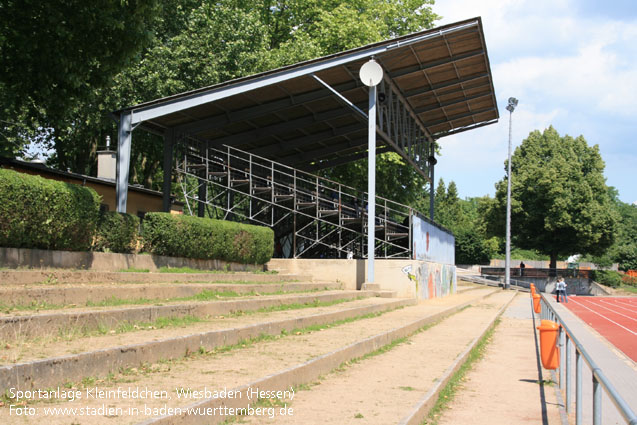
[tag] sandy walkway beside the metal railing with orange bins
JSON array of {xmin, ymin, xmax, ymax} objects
[{"xmin": 438, "ymin": 295, "xmax": 561, "ymax": 425}]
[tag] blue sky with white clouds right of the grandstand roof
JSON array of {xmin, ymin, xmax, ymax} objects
[{"xmin": 433, "ymin": 0, "xmax": 637, "ymax": 203}]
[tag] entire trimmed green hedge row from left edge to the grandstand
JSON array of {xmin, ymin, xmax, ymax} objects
[{"xmin": 0, "ymin": 169, "xmax": 274, "ymax": 264}]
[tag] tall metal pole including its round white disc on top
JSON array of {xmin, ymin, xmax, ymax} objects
[{"xmin": 359, "ymin": 58, "xmax": 383, "ymax": 283}]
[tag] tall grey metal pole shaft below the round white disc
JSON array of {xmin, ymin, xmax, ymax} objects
[{"xmin": 367, "ymin": 86, "xmax": 376, "ymax": 283}]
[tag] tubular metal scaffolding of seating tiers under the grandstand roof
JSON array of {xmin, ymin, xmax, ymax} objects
[{"xmin": 175, "ymin": 135, "xmax": 417, "ymax": 258}]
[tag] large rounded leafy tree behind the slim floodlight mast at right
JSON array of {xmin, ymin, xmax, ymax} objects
[{"xmin": 490, "ymin": 127, "xmax": 617, "ymax": 268}]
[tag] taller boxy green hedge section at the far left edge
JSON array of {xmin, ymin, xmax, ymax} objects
[{"xmin": 0, "ymin": 169, "xmax": 100, "ymax": 251}]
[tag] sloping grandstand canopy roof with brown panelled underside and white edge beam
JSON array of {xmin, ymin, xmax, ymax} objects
[{"xmin": 115, "ymin": 18, "xmax": 499, "ymax": 176}]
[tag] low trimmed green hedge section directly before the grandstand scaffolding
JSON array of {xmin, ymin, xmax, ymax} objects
[{"xmin": 142, "ymin": 213, "xmax": 274, "ymax": 264}]
